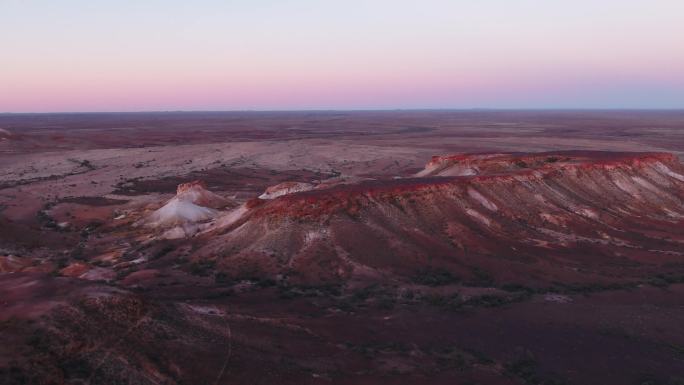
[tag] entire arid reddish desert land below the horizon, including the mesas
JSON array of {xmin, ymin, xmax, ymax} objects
[{"xmin": 0, "ymin": 110, "xmax": 684, "ymax": 385}]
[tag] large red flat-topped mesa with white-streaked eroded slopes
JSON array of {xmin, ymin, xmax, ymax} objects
[{"xmin": 192, "ymin": 152, "xmax": 684, "ymax": 284}]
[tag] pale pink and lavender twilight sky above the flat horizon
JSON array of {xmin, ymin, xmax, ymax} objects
[{"xmin": 0, "ymin": 0, "xmax": 684, "ymax": 112}]
